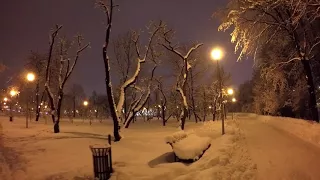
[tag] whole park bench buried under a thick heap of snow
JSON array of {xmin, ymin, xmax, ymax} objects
[{"xmin": 165, "ymin": 131, "xmax": 211, "ymax": 162}]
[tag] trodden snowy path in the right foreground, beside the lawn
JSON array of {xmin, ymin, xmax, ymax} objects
[{"xmin": 239, "ymin": 118, "xmax": 320, "ymax": 180}]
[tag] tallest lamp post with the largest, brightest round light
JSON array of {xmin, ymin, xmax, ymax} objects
[{"xmin": 211, "ymin": 48, "xmax": 225, "ymax": 135}]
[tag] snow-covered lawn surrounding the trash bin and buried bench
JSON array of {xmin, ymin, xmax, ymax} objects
[{"xmin": 0, "ymin": 117, "xmax": 255, "ymax": 180}]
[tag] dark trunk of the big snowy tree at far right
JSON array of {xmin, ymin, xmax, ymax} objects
[{"xmin": 301, "ymin": 59, "xmax": 319, "ymax": 123}]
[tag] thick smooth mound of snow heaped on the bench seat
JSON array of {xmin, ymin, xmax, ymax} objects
[{"xmin": 172, "ymin": 134, "xmax": 211, "ymax": 160}]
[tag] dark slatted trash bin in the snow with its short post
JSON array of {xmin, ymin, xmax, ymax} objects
[{"xmin": 90, "ymin": 135, "xmax": 112, "ymax": 180}]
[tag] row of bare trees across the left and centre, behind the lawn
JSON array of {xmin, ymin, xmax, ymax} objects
[{"xmin": 8, "ymin": 0, "xmax": 235, "ymax": 141}]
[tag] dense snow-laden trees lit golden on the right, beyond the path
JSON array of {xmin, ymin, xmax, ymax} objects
[{"xmin": 218, "ymin": 0, "xmax": 320, "ymax": 122}]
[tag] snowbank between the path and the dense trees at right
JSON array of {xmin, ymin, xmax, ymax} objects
[{"xmin": 259, "ymin": 116, "xmax": 320, "ymax": 147}]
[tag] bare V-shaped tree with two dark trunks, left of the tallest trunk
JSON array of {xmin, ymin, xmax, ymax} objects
[{"xmin": 45, "ymin": 25, "xmax": 89, "ymax": 133}]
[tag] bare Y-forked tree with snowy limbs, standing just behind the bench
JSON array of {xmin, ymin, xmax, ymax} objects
[{"xmin": 161, "ymin": 30, "xmax": 203, "ymax": 130}]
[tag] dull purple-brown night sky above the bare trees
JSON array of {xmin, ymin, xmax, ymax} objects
[{"xmin": 0, "ymin": 0, "xmax": 253, "ymax": 93}]
